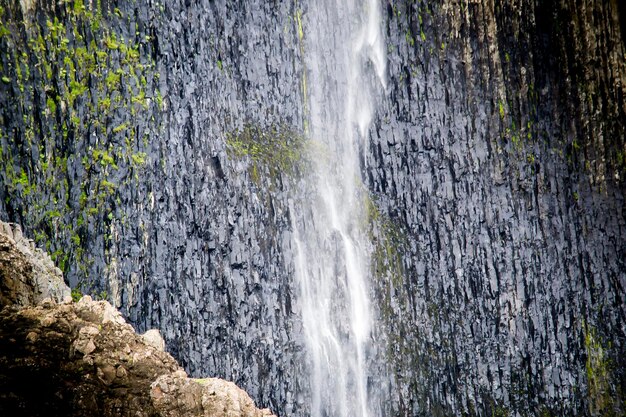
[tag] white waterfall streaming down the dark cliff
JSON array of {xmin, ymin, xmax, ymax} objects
[{"xmin": 291, "ymin": 0, "xmax": 385, "ymax": 417}]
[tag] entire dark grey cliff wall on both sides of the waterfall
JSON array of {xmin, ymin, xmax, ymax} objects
[{"xmin": 0, "ymin": 0, "xmax": 626, "ymax": 415}]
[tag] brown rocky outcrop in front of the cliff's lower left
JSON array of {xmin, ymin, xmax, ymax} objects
[{"xmin": 0, "ymin": 224, "xmax": 272, "ymax": 417}]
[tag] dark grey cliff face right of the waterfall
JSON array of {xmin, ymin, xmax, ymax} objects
[{"xmin": 366, "ymin": 1, "xmax": 626, "ymax": 415}]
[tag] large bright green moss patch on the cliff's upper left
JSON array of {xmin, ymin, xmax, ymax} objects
[{"xmin": 0, "ymin": 0, "xmax": 162, "ymax": 292}]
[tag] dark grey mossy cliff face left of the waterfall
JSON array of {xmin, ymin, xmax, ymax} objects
[{"xmin": 0, "ymin": 1, "xmax": 302, "ymax": 411}]
